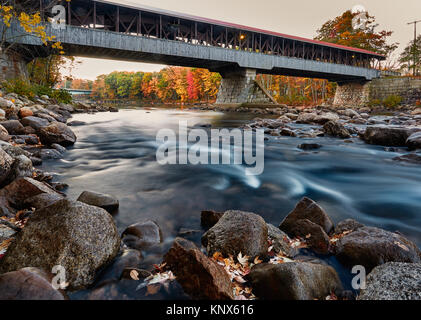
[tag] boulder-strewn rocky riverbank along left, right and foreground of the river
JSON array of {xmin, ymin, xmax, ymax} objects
[{"xmin": 0, "ymin": 90, "xmax": 421, "ymax": 300}]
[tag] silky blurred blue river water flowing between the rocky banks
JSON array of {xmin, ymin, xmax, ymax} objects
[{"xmin": 43, "ymin": 108, "xmax": 421, "ymax": 298}]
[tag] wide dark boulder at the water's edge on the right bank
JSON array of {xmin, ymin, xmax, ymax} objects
[{"xmin": 363, "ymin": 126, "xmax": 411, "ymax": 147}]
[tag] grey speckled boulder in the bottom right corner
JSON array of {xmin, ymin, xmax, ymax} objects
[{"xmin": 357, "ymin": 262, "xmax": 421, "ymax": 300}]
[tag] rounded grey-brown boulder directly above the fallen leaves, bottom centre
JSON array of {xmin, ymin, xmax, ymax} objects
[{"xmin": 202, "ymin": 210, "xmax": 268, "ymax": 259}]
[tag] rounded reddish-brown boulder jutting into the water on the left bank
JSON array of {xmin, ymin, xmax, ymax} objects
[{"xmin": 37, "ymin": 118, "xmax": 76, "ymax": 146}]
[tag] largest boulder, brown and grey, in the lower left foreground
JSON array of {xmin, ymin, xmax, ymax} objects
[{"xmin": 0, "ymin": 199, "xmax": 120, "ymax": 290}]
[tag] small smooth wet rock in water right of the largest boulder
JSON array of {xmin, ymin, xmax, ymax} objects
[{"xmin": 121, "ymin": 220, "xmax": 163, "ymax": 250}]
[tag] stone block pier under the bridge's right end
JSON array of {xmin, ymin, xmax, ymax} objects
[{"xmin": 333, "ymin": 82, "xmax": 370, "ymax": 107}]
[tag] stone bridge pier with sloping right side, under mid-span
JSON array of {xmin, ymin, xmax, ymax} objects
[{"xmin": 216, "ymin": 69, "xmax": 274, "ymax": 106}]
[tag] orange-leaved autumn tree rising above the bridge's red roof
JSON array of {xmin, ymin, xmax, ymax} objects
[{"xmin": 315, "ymin": 10, "xmax": 398, "ymax": 64}]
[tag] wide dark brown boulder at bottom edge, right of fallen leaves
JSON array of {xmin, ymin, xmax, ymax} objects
[{"xmin": 246, "ymin": 262, "xmax": 342, "ymax": 300}]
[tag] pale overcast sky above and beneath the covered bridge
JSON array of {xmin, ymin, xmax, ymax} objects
[{"xmin": 63, "ymin": 0, "xmax": 421, "ymax": 80}]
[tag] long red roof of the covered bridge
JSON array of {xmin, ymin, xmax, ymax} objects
[{"xmin": 94, "ymin": 0, "xmax": 386, "ymax": 59}]
